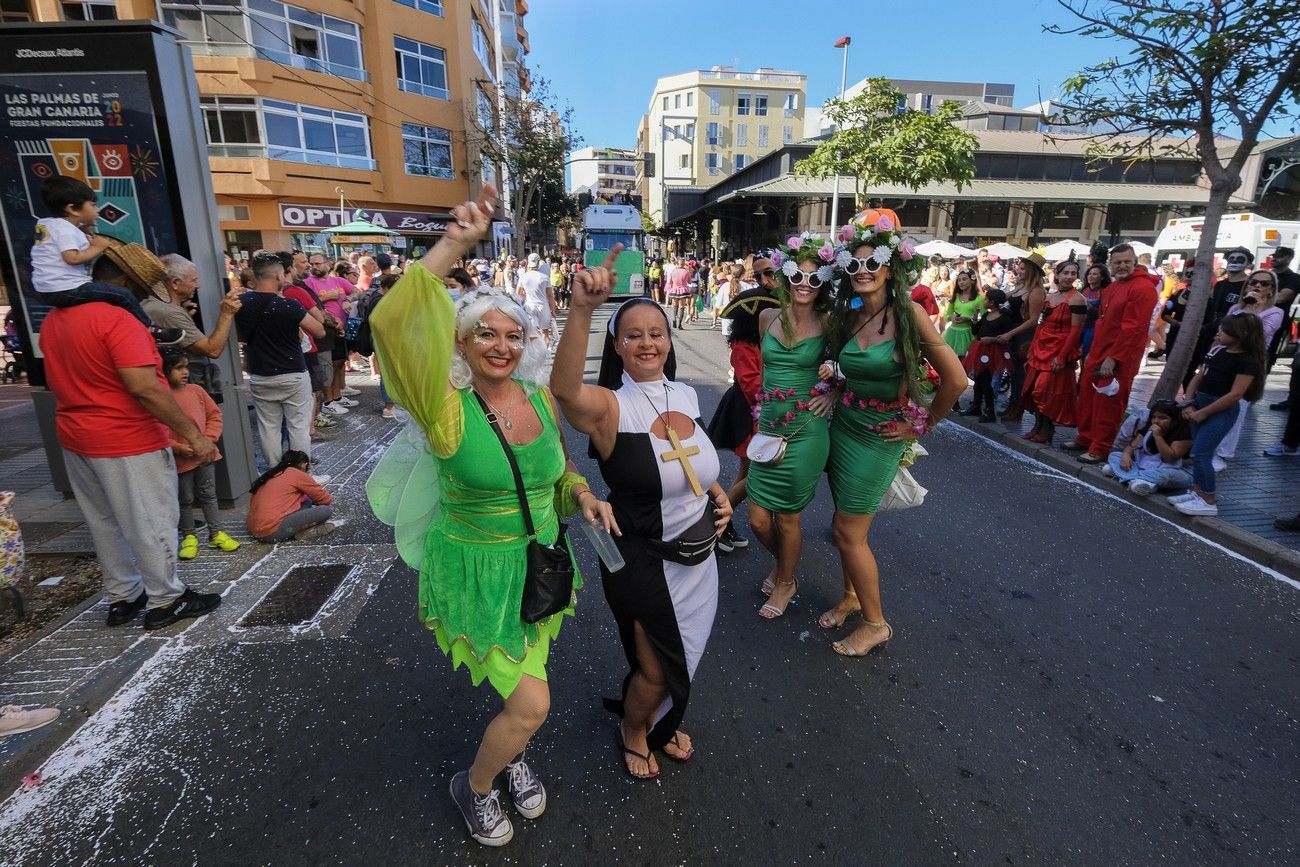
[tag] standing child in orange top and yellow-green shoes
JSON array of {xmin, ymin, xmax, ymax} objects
[{"xmin": 163, "ymin": 352, "xmax": 239, "ymax": 560}]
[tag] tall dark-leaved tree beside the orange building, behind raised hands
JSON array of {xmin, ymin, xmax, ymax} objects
[{"xmin": 465, "ymin": 77, "xmax": 581, "ymax": 256}]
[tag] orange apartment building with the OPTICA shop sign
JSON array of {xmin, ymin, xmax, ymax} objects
[{"xmin": 10, "ymin": 0, "xmax": 529, "ymax": 253}]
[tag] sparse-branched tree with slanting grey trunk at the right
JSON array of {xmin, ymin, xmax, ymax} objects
[{"xmin": 1044, "ymin": 0, "xmax": 1300, "ymax": 400}]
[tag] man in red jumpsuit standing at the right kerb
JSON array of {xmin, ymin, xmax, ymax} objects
[{"xmin": 1066, "ymin": 244, "xmax": 1161, "ymax": 464}]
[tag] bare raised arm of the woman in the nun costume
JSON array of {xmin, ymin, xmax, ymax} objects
[{"xmin": 551, "ymin": 244, "xmax": 623, "ymax": 455}]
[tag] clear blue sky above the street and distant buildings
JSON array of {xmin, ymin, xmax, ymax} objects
[{"xmin": 525, "ymin": 0, "xmax": 1118, "ymax": 148}]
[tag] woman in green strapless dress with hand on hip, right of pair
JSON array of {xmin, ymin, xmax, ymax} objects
[{"xmin": 818, "ymin": 211, "xmax": 966, "ymax": 656}]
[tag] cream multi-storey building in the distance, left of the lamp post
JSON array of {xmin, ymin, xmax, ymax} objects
[{"xmin": 636, "ymin": 66, "xmax": 807, "ymax": 222}]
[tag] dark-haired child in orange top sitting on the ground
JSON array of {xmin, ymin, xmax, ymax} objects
[{"xmin": 248, "ymin": 448, "xmax": 342, "ymax": 542}]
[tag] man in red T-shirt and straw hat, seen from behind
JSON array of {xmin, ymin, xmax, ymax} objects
[{"xmin": 40, "ymin": 244, "xmax": 221, "ymax": 629}]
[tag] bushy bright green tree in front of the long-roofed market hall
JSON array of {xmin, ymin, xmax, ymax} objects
[{"xmin": 794, "ymin": 78, "xmax": 979, "ymax": 210}]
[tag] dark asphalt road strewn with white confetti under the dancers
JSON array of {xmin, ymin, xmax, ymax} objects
[{"xmin": 0, "ymin": 308, "xmax": 1300, "ymax": 867}]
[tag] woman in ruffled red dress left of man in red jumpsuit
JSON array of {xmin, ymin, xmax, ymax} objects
[{"xmin": 1021, "ymin": 260, "xmax": 1088, "ymax": 442}]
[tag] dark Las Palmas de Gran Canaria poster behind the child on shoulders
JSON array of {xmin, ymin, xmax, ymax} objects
[{"xmin": 0, "ymin": 71, "xmax": 176, "ymax": 356}]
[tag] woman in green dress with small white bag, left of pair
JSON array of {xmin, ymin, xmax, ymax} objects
[{"xmin": 749, "ymin": 245, "xmax": 833, "ymax": 620}]
